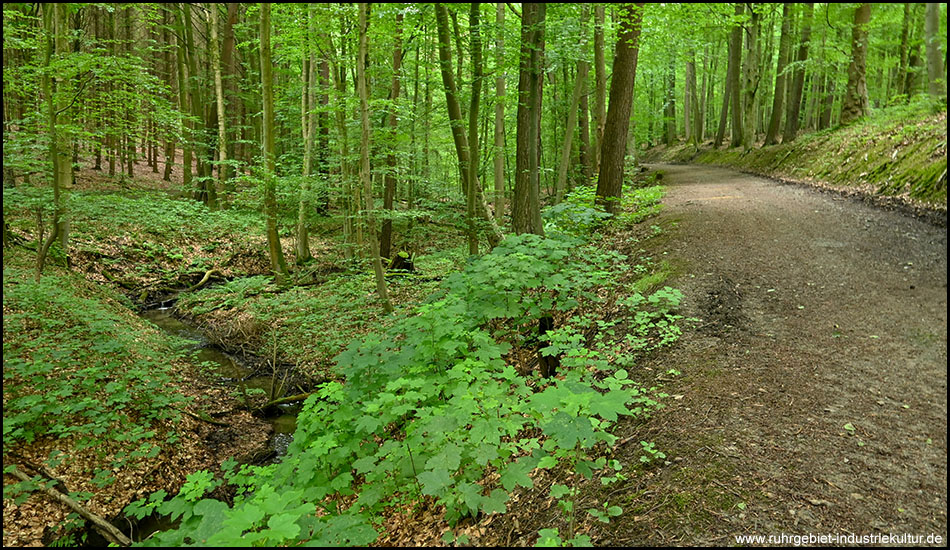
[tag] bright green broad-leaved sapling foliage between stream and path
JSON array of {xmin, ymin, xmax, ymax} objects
[{"xmin": 136, "ymin": 210, "xmax": 678, "ymax": 545}]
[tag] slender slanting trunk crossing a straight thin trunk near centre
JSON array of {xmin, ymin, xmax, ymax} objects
[{"xmin": 434, "ymin": 3, "xmax": 504, "ymax": 248}]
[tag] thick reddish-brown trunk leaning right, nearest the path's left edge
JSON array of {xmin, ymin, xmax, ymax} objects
[{"xmin": 596, "ymin": 3, "xmax": 643, "ymax": 214}]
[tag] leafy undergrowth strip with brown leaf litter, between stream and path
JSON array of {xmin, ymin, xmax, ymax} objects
[{"xmin": 129, "ymin": 181, "xmax": 692, "ymax": 546}]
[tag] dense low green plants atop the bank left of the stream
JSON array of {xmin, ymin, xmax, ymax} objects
[{"xmin": 3, "ymin": 267, "xmax": 184, "ymax": 498}]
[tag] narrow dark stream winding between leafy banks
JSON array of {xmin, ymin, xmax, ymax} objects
[{"xmin": 140, "ymin": 307, "xmax": 299, "ymax": 460}]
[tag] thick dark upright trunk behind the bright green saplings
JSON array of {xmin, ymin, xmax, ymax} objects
[{"xmin": 511, "ymin": 3, "xmax": 546, "ymax": 235}]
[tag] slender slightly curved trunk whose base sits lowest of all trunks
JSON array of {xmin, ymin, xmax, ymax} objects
[{"xmin": 356, "ymin": 2, "xmax": 393, "ymax": 313}]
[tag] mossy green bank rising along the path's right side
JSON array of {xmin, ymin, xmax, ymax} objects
[{"xmin": 645, "ymin": 98, "xmax": 947, "ymax": 212}]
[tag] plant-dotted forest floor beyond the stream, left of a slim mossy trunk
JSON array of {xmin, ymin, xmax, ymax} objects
[{"xmin": 3, "ymin": 185, "xmax": 269, "ymax": 303}]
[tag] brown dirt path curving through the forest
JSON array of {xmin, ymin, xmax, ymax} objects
[{"xmin": 598, "ymin": 165, "xmax": 947, "ymax": 545}]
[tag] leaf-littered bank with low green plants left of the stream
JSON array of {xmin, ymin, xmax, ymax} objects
[{"xmin": 3, "ymin": 248, "xmax": 265, "ymax": 546}]
